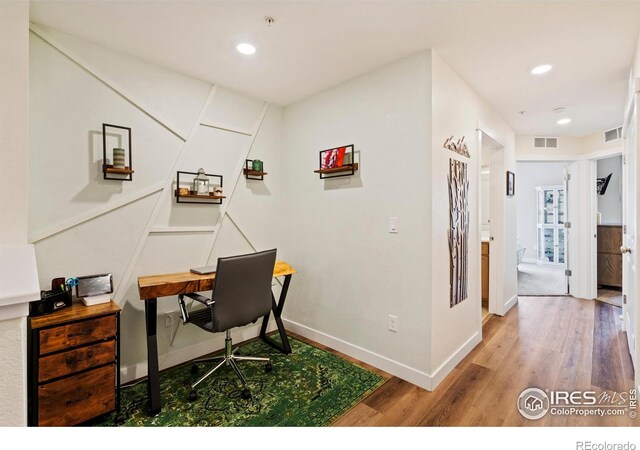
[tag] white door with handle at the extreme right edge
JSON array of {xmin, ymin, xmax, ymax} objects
[{"xmin": 622, "ymin": 96, "xmax": 640, "ymax": 370}]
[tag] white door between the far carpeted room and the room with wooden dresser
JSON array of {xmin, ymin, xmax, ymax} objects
[{"xmin": 565, "ymin": 160, "xmax": 598, "ymax": 299}]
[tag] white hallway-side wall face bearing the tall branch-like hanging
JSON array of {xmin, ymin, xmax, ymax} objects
[{"xmin": 430, "ymin": 53, "xmax": 516, "ymax": 382}]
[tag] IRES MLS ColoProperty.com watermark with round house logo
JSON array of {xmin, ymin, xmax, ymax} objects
[{"xmin": 518, "ymin": 388, "xmax": 638, "ymax": 420}]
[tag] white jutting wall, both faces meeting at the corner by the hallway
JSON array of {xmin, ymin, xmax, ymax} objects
[{"xmin": 285, "ymin": 52, "xmax": 516, "ymax": 388}]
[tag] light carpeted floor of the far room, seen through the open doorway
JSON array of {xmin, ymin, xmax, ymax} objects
[{"xmin": 518, "ymin": 262, "xmax": 567, "ymax": 296}]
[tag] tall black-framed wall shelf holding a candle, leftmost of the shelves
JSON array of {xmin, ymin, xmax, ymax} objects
[{"xmin": 102, "ymin": 123, "xmax": 134, "ymax": 181}]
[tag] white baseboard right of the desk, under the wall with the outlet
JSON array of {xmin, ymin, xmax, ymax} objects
[{"xmin": 283, "ymin": 319, "xmax": 431, "ymax": 390}]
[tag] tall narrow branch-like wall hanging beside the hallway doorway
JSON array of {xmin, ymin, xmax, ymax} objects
[{"xmin": 448, "ymin": 159, "xmax": 469, "ymax": 308}]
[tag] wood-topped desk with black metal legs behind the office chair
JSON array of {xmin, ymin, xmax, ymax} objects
[{"xmin": 138, "ymin": 261, "xmax": 296, "ymax": 414}]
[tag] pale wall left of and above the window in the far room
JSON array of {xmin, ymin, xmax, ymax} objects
[{"xmin": 516, "ymin": 162, "xmax": 569, "ymax": 259}]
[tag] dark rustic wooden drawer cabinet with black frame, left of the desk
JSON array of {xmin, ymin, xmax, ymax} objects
[{"xmin": 28, "ymin": 302, "xmax": 120, "ymax": 426}]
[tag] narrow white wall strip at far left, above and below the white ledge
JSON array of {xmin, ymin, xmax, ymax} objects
[{"xmin": 0, "ymin": 1, "xmax": 30, "ymax": 426}]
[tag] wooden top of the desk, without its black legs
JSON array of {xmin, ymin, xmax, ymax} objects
[{"xmin": 138, "ymin": 261, "xmax": 296, "ymax": 300}]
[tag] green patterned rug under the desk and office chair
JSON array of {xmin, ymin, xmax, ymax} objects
[{"xmin": 88, "ymin": 337, "xmax": 386, "ymax": 427}]
